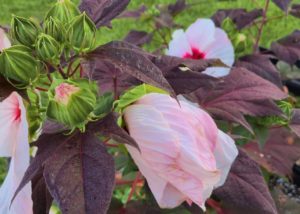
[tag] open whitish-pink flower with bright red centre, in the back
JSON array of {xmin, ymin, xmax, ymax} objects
[{"xmin": 167, "ymin": 19, "xmax": 234, "ymax": 77}]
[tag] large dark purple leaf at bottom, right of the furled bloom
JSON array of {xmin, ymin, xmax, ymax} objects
[{"xmin": 214, "ymin": 151, "xmax": 277, "ymax": 214}]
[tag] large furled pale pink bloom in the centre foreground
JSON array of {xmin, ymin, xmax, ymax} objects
[{"xmin": 124, "ymin": 93, "xmax": 238, "ymax": 209}]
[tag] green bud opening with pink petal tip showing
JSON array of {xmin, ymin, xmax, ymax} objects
[{"xmin": 47, "ymin": 79, "xmax": 98, "ymax": 130}]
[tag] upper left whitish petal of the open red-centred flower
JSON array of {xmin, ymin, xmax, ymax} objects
[{"xmin": 166, "ymin": 30, "xmax": 192, "ymax": 57}]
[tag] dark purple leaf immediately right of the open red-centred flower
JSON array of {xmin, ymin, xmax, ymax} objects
[{"xmin": 236, "ymin": 54, "xmax": 282, "ymax": 88}]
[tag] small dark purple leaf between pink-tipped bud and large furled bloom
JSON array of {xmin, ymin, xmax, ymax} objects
[{"xmin": 88, "ymin": 113, "xmax": 138, "ymax": 148}]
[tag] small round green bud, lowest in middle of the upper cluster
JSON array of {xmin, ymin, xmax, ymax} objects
[{"xmin": 35, "ymin": 33, "xmax": 61, "ymax": 64}]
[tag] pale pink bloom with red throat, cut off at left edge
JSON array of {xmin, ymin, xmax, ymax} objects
[{"xmin": 0, "ymin": 92, "xmax": 32, "ymax": 214}]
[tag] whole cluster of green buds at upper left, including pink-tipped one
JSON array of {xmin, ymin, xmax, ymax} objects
[{"xmin": 0, "ymin": 0, "xmax": 99, "ymax": 129}]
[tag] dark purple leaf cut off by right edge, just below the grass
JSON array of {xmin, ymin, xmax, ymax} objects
[{"xmin": 271, "ymin": 30, "xmax": 300, "ymax": 65}]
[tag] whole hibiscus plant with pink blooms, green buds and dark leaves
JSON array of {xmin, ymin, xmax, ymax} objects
[{"xmin": 0, "ymin": 0, "xmax": 300, "ymax": 214}]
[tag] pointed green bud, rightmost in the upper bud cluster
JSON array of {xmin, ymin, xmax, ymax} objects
[{"xmin": 68, "ymin": 12, "xmax": 96, "ymax": 53}]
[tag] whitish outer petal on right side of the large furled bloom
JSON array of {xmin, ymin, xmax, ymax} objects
[{"xmin": 214, "ymin": 130, "xmax": 238, "ymax": 187}]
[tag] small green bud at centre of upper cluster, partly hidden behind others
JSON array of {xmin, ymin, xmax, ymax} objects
[{"xmin": 44, "ymin": 17, "xmax": 66, "ymax": 43}]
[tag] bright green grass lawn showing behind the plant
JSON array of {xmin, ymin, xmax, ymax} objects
[{"xmin": 0, "ymin": 0, "xmax": 300, "ymax": 190}]
